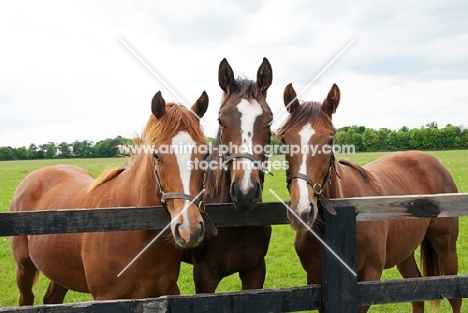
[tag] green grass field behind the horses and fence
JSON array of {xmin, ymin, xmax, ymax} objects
[{"xmin": 0, "ymin": 150, "xmax": 468, "ymax": 312}]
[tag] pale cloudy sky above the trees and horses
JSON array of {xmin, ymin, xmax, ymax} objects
[{"xmin": 0, "ymin": 0, "xmax": 468, "ymax": 147}]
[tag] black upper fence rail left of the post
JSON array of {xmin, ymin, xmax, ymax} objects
[{"xmin": 0, "ymin": 202, "xmax": 288, "ymax": 236}]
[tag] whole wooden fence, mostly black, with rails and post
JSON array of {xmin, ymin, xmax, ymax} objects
[{"xmin": 0, "ymin": 194, "xmax": 468, "ymax": 313}]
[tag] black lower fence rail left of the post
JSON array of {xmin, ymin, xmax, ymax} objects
[{"xmin": 0, "ymin": 285, "xmax": 320, "ymax": 313}]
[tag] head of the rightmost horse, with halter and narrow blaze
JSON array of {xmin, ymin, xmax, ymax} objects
[{"xmin": 277, "ymin": 84, "xmax": 340, "ymax": 230}]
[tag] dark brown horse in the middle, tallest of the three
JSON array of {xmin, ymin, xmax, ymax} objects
[{"xmin": 184, "ymin": 58, "xmax": 273, "ymax": 293}]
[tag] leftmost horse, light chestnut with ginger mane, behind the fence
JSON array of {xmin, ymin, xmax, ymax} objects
[{"xmin": 11, "ymin": 92, "xmax": 216, "ymax": 305}]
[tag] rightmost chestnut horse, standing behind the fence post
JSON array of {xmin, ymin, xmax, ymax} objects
[{"xmin": 277, "ymin": 84, "xmax": 461, "ymax": 312}]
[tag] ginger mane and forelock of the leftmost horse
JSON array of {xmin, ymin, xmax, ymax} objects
[{"xmin": 87, "ymin": 102, "xmax": 206, "ymax": 192}]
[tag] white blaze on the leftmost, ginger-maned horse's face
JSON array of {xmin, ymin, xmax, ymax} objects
[{"xmin": 171, "ymin": 131, "xmax": 195, "ymax": 229}]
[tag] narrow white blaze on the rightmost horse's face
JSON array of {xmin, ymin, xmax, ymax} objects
[{"xmin": 296, "ymin": 123, "xmax": 315, "ymax": 215}]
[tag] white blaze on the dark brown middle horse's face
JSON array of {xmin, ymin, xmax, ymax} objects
[{"xmin": 237, "ymin": 99, "xmax": 263, "ymax": 194}]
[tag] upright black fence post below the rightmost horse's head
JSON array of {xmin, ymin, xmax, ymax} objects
[{"xmin": 320, "ymin": 206, "xmax": 358, "ymax": 313}]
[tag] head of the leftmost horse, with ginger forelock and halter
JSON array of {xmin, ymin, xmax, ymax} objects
[{"xmin": 143, "ymin": 92, "xmax": 215, "ymax": 248}]
